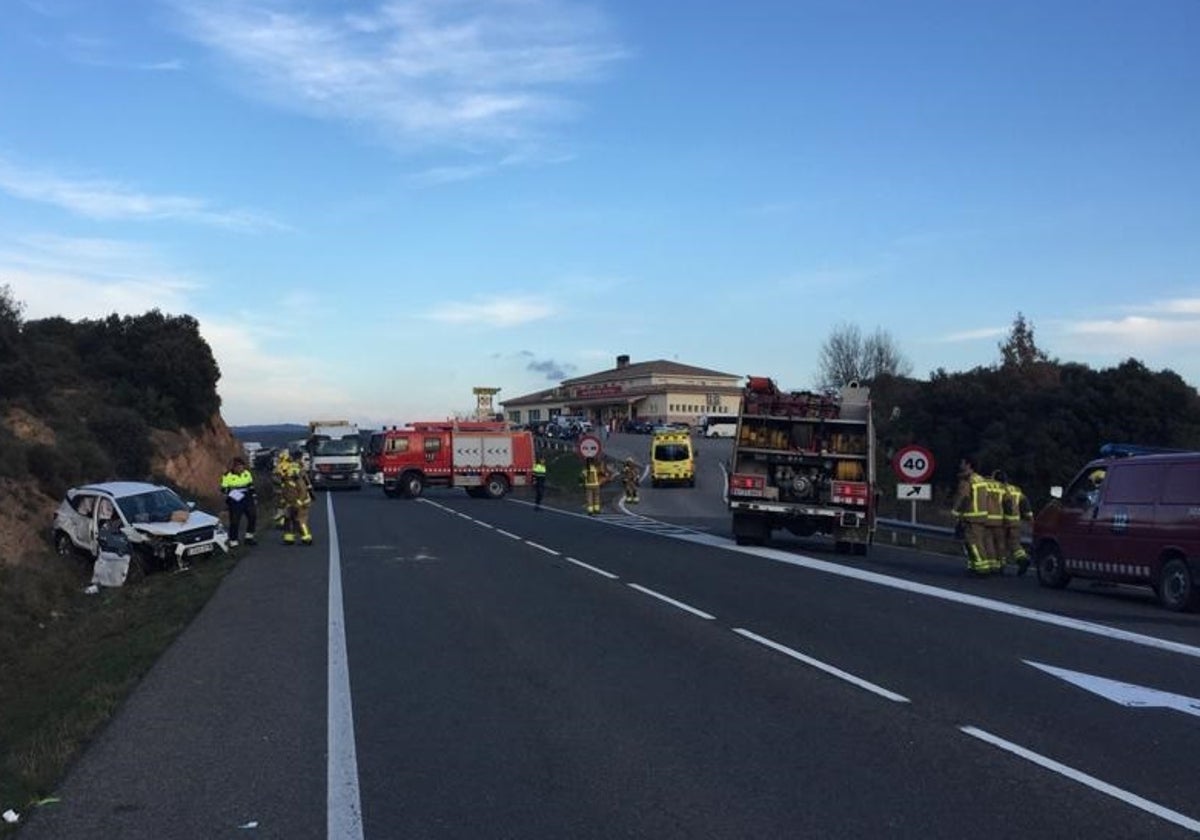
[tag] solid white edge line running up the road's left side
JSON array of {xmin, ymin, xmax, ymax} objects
[{"xmin": 325, "ymin": 493, "xmax": 362, "ymax": 840}]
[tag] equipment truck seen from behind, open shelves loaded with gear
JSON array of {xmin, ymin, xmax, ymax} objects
[{"xmin": 728, "ymin": 377, "xmax": 875, "ymax": 554}]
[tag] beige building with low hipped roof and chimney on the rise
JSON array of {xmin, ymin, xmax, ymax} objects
[{"xmin": 500, "ymin": 355, "xmax": 742, "ymax": 427}]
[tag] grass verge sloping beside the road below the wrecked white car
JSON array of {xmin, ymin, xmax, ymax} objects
[{"xmin": 0, "ymin": 552, "xmax": 236, "ymax": 838}]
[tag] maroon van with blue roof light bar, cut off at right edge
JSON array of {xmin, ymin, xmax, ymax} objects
[{"xmin": 1033, "ymin": 452, "xmax": 1200, "ymax": 611}]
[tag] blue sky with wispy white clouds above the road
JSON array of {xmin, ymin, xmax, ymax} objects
[{"xmin": 0, "ymin": 0, "xmax": 1200, "ymax": 425}]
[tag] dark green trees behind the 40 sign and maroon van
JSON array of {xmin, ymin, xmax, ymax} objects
[{"xmin": 871, "ymin": 314, "xmax": 1200, "ymax": 504}]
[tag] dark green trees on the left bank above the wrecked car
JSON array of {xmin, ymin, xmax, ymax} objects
[{"xmin": 0, "ymin": 286, "xmax": 221, "ymax": 496}]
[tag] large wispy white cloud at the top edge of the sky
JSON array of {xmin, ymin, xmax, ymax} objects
[{"xmin": 176, "ymin": 0, "xmax": 623, "ymax": 153}]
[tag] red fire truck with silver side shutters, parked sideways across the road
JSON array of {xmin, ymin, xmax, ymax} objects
[{"xmin": 372, "ymin": 420, "xmax": 533, "ymax": 499}]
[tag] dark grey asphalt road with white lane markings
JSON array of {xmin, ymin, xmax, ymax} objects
[{"xmin": 22, "ymin": 458, "xmax": 1200, "ymax": 839}]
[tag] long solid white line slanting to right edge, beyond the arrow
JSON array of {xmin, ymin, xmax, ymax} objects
[{"xmin": 672, "ymin": 534, "xmax": 1200, "ymax": 659}]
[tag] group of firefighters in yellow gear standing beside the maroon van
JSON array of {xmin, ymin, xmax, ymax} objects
[{"xmin": 953, "ymin": 457, "xmax": 1033, "ymax": 575}]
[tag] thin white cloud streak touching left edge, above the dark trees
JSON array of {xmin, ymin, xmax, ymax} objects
[{"xmin": 0, "ymin": 157, "xmax": 283, "ymax": 230}]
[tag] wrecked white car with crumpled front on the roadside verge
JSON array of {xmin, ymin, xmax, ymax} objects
[{"xmin": 54, "ymin": 481, "xmax": 229, "ymax": 571}]
